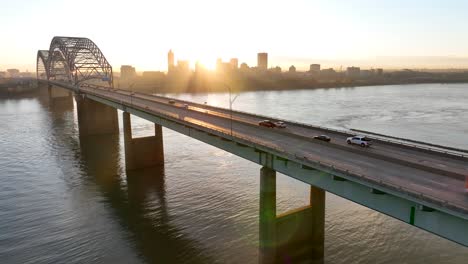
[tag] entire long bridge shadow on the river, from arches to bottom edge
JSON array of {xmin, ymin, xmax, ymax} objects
[{"xmin": 34, "ymin": 88, "xmax": 213, "ymax": 263}]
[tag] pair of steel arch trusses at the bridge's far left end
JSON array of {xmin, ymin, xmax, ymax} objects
[{"xmin": 37, "ymin": 37, "xmax": 113, "ymax": 87}]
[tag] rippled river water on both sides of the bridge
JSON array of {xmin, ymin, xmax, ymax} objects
[{"xmin": 0, "ymin": 84, "xmax": 468, "ymax": 263}]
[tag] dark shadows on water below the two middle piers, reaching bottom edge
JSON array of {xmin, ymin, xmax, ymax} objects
[{"xmin": 79, "ymin": 135, "xmax": 212, "ymax": 263}]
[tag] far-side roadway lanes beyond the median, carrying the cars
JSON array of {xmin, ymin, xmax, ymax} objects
[{"xmin": 113, "ymin": 90, "xmax": 468, "ymax": 179}]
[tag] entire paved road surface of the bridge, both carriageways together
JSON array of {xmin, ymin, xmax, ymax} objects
[{"xmin": 81, "ymin": 87, "xmax": 468, "ymax": 215}]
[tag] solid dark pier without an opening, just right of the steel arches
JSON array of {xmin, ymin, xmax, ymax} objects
[{"xmin": 75, "ymin": 94, "xmax": 119, "ymax": 136}]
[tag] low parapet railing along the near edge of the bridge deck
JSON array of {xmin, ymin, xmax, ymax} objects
[{"xmin": 78, "ymin": 85, "xmax": 468, "ymax": 219}]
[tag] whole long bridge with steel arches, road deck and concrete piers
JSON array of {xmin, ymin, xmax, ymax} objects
[{"xmin": 37, "ymin": 37, "xmax": 468, "ymax": 263}]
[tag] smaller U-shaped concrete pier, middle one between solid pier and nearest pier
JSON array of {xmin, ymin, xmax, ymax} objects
[{"xmin": 123, "ymin": 112, "xmax": 164, "ymax": 171}]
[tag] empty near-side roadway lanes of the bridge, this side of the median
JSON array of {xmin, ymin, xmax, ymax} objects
[{"xmin": 83, "ymin": 88, "xmax": 468, "ymax": 213}]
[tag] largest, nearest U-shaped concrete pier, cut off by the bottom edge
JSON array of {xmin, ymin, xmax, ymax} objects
[{"xmin": 259, "ymin": 167, "xmax": 325, "ymax": 264}]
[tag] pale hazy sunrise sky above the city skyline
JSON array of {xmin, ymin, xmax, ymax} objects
[{"xmin": 0, "ymin": 0, "xmax": 468, "ymax": 71}]
